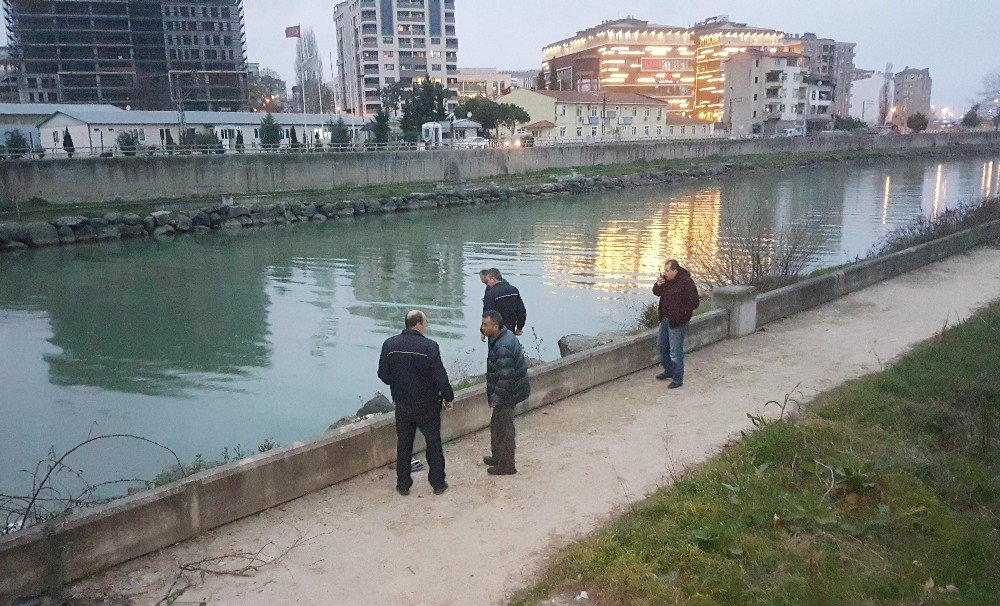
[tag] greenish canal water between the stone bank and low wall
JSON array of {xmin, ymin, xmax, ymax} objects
[{"xmin": 0, "ymin": 156, "xmax": 1000, "ymax": 493}]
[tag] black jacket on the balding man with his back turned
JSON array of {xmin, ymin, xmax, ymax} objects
[{"xmin": 378, "ymin": 329, "xmax": 455, "ymax": 416}]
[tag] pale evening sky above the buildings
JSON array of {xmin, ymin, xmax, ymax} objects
[{"xmin": 244, "ymin": 0, "xmax": 1000, "ymax": 111}]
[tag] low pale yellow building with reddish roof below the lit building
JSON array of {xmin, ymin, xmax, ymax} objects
[{"xmin": 499, "ymin": 89, "xmax": 715, "ymax": 142}]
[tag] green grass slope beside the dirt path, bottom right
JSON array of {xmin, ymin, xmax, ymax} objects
[{"xmin": 513, "ymin": 303, "xmax": 1000, "ymax": 606}]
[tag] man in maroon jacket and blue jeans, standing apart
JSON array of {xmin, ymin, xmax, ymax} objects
[{"xmin": 653, "ymin": 259, "xmax": 700, "ymax": 389}]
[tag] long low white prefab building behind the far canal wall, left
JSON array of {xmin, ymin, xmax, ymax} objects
[{"xmin": 38, "ymin": 106, "xmax": 374, "ymax": 157}]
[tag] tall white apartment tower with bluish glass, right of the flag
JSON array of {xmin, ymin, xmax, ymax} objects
[{"xmin": 333, "ymin": 0, "xmax": 458, "ymax": 116}]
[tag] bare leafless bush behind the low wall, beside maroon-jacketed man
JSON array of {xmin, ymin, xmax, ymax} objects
[{"xmin": 689, "ymin": 200, "xmax": 820, "ymax": 291}]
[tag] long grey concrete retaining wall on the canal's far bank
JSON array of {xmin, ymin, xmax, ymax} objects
[{"xmin": 0, "ymin": 132, "xmax": 1000, "ymax": 204}]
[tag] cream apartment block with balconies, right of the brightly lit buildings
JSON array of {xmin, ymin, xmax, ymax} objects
[{"xmin": 723, "ymin": 50, "xmax": 818, "ymax": 136}]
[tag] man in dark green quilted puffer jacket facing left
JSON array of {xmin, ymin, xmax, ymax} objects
[{"xmin": 480, "ymin": 311, "xmax": 531, "ymax": 476}]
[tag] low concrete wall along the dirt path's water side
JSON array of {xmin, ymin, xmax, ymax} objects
[{"xmin": 0, "ymin": 221, "xmax": 1000, "ymax": 603}]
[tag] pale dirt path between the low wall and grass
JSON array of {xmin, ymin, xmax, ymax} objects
[{"xmin": 77, "ymin": 247, "xmax": 1000, "ymax": 606}]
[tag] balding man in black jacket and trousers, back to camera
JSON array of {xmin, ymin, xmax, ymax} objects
[{"xmin": 378, "ymin": 311, "xmax": 455, "ymax": 496}]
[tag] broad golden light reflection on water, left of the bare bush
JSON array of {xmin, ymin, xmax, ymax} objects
[{"xmin": 543, "ymin": 187, "xmax": 722, "ymax": 293}]
